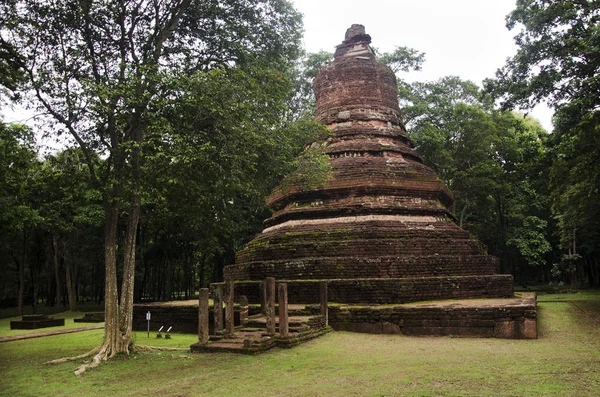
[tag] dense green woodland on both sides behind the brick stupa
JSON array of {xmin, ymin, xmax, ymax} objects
[{"xmin": 0, "ymin": 0, "xmax": 600, "ymax": 316}]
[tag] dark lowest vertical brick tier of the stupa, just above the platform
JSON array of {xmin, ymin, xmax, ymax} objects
[{"xmin": 235, "ymin": 275, "xmax": 513, "ymax": 304}]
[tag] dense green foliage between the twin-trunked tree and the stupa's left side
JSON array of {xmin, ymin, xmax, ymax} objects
[{"xmin": 137, "ymin": 65, "xmax": 321, "ymax": 292}]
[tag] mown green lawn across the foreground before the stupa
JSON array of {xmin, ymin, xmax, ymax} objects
[{"xmin": 0, "ymin": 292, "xmax": 600, "ymax": 396}]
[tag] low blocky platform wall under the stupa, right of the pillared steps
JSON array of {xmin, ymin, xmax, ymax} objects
[{"xmin": 314, "ymin": 294, "xmax": 537, "ymax": 339}]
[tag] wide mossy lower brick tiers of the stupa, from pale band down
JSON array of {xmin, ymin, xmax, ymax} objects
[{"xmin": 225, "ymin": 215, "xmax": 513, "ymax": 304}]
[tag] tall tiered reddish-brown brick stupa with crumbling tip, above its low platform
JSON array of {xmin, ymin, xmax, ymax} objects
[{"xmin": 224, "ymin": 25, "xmax": 540, "ymax": 336}]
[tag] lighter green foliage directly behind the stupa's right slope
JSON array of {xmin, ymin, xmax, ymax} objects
[{"xmin": 399, "ymin": 77, "xmax": 550, "ymax": 272}]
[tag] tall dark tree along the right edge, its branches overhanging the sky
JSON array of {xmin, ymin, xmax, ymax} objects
[{"xmin": 486, "ymin": 0, "xmax": 600, "ymax": 285}]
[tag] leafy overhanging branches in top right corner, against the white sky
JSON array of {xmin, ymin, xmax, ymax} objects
[{"xmin": 486, "ymin": 0, "xmax": 600, "ymax": 131}]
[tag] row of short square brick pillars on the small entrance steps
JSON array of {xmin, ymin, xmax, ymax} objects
[{"xmin": 198, "ymin": 277, "xmax": 328, "ymax": 344}]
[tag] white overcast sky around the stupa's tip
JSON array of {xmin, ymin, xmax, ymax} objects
[{"xmin": 292, "ymin": 0, "xmax": 552, "ymax": 131}]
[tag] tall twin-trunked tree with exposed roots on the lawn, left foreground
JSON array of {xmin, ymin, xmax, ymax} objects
[{"xmin": 0, "ymin": 0, "xmax": 300, "ymax": 374}]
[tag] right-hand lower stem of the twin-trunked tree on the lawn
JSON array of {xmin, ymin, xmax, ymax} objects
[{"xmin": 119, "ymin": 195, "xmax": 141, "ymax": 345}]
